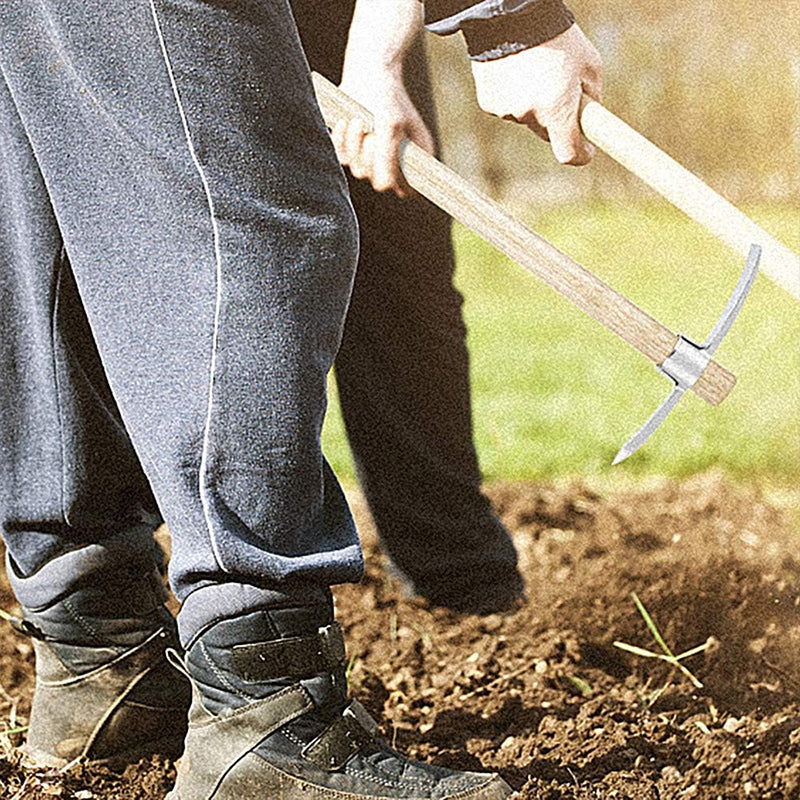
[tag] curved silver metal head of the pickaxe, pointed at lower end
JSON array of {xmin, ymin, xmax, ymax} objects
[{"xmin": 613, "ymin": 244, "xmax": 761, "ymax": 464}]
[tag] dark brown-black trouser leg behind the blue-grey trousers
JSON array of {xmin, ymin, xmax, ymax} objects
[{"xmin": 328, "ymin": 42, "xmax": 522, "ymax": 611}]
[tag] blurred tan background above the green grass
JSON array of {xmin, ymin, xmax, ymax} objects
[{"xmin": 427, "ymin": 0, "xmax": 800, "ymax": 205}]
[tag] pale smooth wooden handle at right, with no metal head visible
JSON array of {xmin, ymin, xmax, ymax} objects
[{"xmin": 581, "ymin": 100, "xmax": 800, "ymax": 300}]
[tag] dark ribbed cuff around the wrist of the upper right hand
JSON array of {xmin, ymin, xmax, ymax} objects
[{"xmin": 461, "ymin": 0, "xmax": 575, "ymax": 61}]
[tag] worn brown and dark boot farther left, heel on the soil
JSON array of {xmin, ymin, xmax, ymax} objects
[{"xmin": 8, "ymin": 536, "xmax": 191, "ymax": 769}]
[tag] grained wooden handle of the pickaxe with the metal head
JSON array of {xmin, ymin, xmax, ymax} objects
[{"xmin": 313, "ymin": 73, "xmax": 736, "ymax": 405}]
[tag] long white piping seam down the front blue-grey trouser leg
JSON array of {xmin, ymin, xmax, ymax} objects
[{"xmin": 148, "ymin": 0, "xmax": 226, "ymax": 572}]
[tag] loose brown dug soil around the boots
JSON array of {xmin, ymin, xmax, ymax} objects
[{"xmin": 0, "ymin": 474, "xmax": 800, "ymax": 800}]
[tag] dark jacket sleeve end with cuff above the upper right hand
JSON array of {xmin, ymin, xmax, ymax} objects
[{"xmin": 423, "ymin": 0, "xmax": 575, "ymax": 61}]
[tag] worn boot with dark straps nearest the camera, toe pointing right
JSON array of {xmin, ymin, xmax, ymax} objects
[{"xmin": 172, "ymin": 606, "xmax": 512, "ymax": 800}]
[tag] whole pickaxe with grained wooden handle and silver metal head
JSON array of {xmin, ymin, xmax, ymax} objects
[{"xmin": 312, "ymin": 73, "xmax": 800, "ymax": 463}]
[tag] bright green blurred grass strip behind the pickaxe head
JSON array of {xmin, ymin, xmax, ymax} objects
[{"xmin": 323, "ymin": 203, "xmax": 800, "ymax": 486}]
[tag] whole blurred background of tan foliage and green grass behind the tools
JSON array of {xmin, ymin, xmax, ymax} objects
[{"xmin": 324, "ymin": 0, "xmax": 800, "ymax": 488}]
